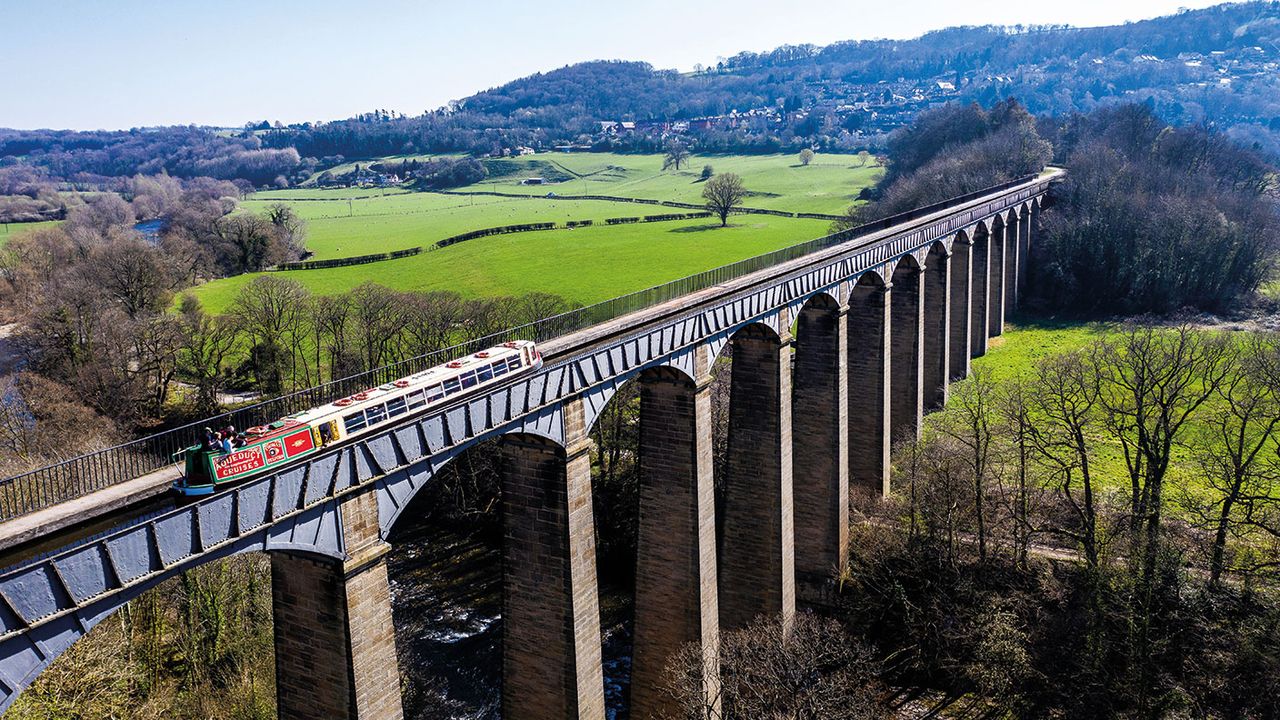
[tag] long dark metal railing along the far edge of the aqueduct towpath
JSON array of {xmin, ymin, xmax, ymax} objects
[{"xmin": 0, "ymin": 176, "xmax": 1037, "ymax": 521}]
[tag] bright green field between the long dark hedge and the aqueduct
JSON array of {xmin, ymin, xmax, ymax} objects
[{"xmin": 192, "ymin": 215, "xmax": 828, "ymax": 311}]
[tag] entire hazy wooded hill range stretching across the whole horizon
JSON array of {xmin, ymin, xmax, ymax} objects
[{"xmin": 0, "ymin": 1, "xmax": 1280, "ymax": 184}]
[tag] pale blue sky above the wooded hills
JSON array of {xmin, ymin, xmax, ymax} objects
[{"xmin": 0, "ymin": 0, "xmax": 1233, "ymax": 129}]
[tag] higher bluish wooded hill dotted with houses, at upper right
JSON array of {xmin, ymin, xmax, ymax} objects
[{"xmin": 432, "ymin": 1, "xmax": 1280, "ymax": 149}]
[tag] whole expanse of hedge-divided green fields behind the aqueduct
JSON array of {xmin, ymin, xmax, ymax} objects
[{"xmin": 195, "ymin": 152, "xmax": 881, "ymax": 310}]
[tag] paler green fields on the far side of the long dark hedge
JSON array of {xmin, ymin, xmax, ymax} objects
[{"xmin": 243, "ymin": 152, "xmax": 881, "ymax": 260}]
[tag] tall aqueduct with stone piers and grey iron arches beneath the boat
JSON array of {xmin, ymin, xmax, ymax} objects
[{"xmin": 0, "ymin": 173, "xmax": 1055, "ymax": 720}]
